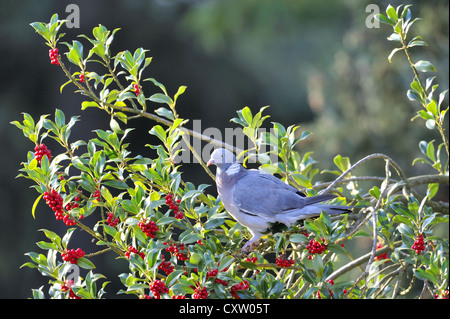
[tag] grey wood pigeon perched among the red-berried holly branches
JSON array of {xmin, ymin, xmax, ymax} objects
[{"xmin": 207, "ymin": 148, "xmax": 352, "ymax": 251}]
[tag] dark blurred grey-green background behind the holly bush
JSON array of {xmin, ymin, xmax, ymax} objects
[{"xmin": 0, "ymin": 0, "xmax": 449, "ymax": 298}]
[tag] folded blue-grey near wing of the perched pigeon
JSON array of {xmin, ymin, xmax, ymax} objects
[{"xmin": 233, "ymin": 171, "xmax": 306, "ymax": 218}]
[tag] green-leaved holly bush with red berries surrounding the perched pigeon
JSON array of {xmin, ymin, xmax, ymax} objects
[{"xmin": 13, "ymin": 5, "xmax": 449, "ymax": 299}]
